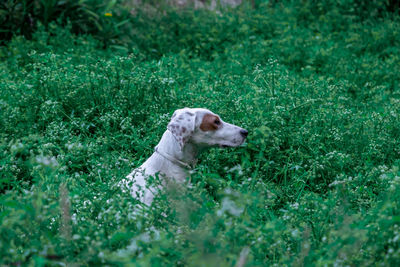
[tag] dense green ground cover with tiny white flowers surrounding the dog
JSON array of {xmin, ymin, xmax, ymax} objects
[{"xmin": 0, "ymin": 1, "xmax": 400, "ymax": 266}]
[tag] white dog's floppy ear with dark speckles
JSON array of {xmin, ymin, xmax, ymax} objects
[{"xmin": 167, "ymin": 108, "xmax": 196, "ymax": 149}]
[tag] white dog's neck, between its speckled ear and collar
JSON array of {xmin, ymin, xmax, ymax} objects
[{"xmin": 157, "ymin": 130, "xmax": 200, "ymax": 169}]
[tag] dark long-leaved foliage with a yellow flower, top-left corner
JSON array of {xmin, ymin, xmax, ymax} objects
[{"xmin": 0, "ymin": 0, "xmax": 129, "ymax": 45}]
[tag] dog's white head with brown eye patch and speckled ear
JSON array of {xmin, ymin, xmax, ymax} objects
[{"xmin": 167, "ymin": 108, "xmax": 248, "ymax": 148}]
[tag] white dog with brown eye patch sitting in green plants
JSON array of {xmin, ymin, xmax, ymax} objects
[{"xmin": 127, "ymin": 108, "xmax": 248, "ymax": 205}]
